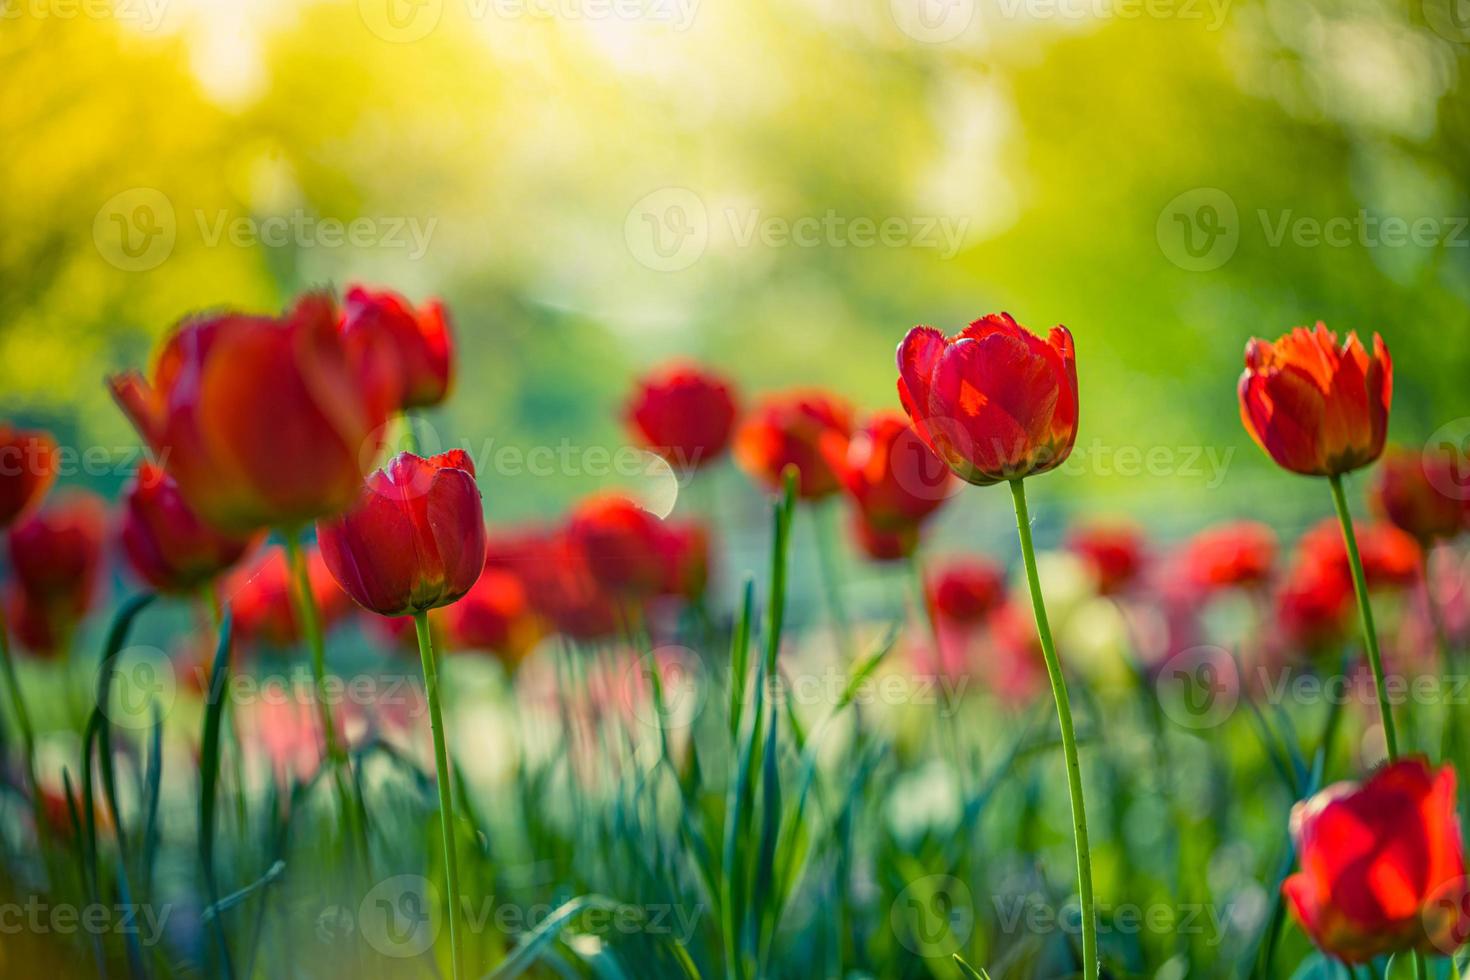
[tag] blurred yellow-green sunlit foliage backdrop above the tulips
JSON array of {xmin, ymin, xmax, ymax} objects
[{"xmin": 0, "ymin": 0, "xmax": 1470, "ymax": 537}]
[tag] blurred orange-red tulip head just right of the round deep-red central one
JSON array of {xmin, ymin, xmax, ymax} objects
[{"xmin": 735, "ymin": 391, "xmax": 853, "ymax": 500}]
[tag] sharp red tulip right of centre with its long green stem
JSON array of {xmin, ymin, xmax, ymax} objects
[{"xmin": 898, "ymin": 313, "xmax": 1098, "ymax": 980}]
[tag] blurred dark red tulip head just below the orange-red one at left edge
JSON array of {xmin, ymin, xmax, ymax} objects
[{"xmin": 10, "ymin": 491, "xmax": 107, "ymax": 624}]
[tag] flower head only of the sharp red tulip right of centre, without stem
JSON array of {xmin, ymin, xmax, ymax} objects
[{"xmin": 898, "ymin": 313, "xmax": 1078, "ymax": 486}]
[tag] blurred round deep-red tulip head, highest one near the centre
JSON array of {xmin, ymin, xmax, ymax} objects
[{"xmin": 626, "ymin": 363, "xmax": 735, "ymax": 470}]
